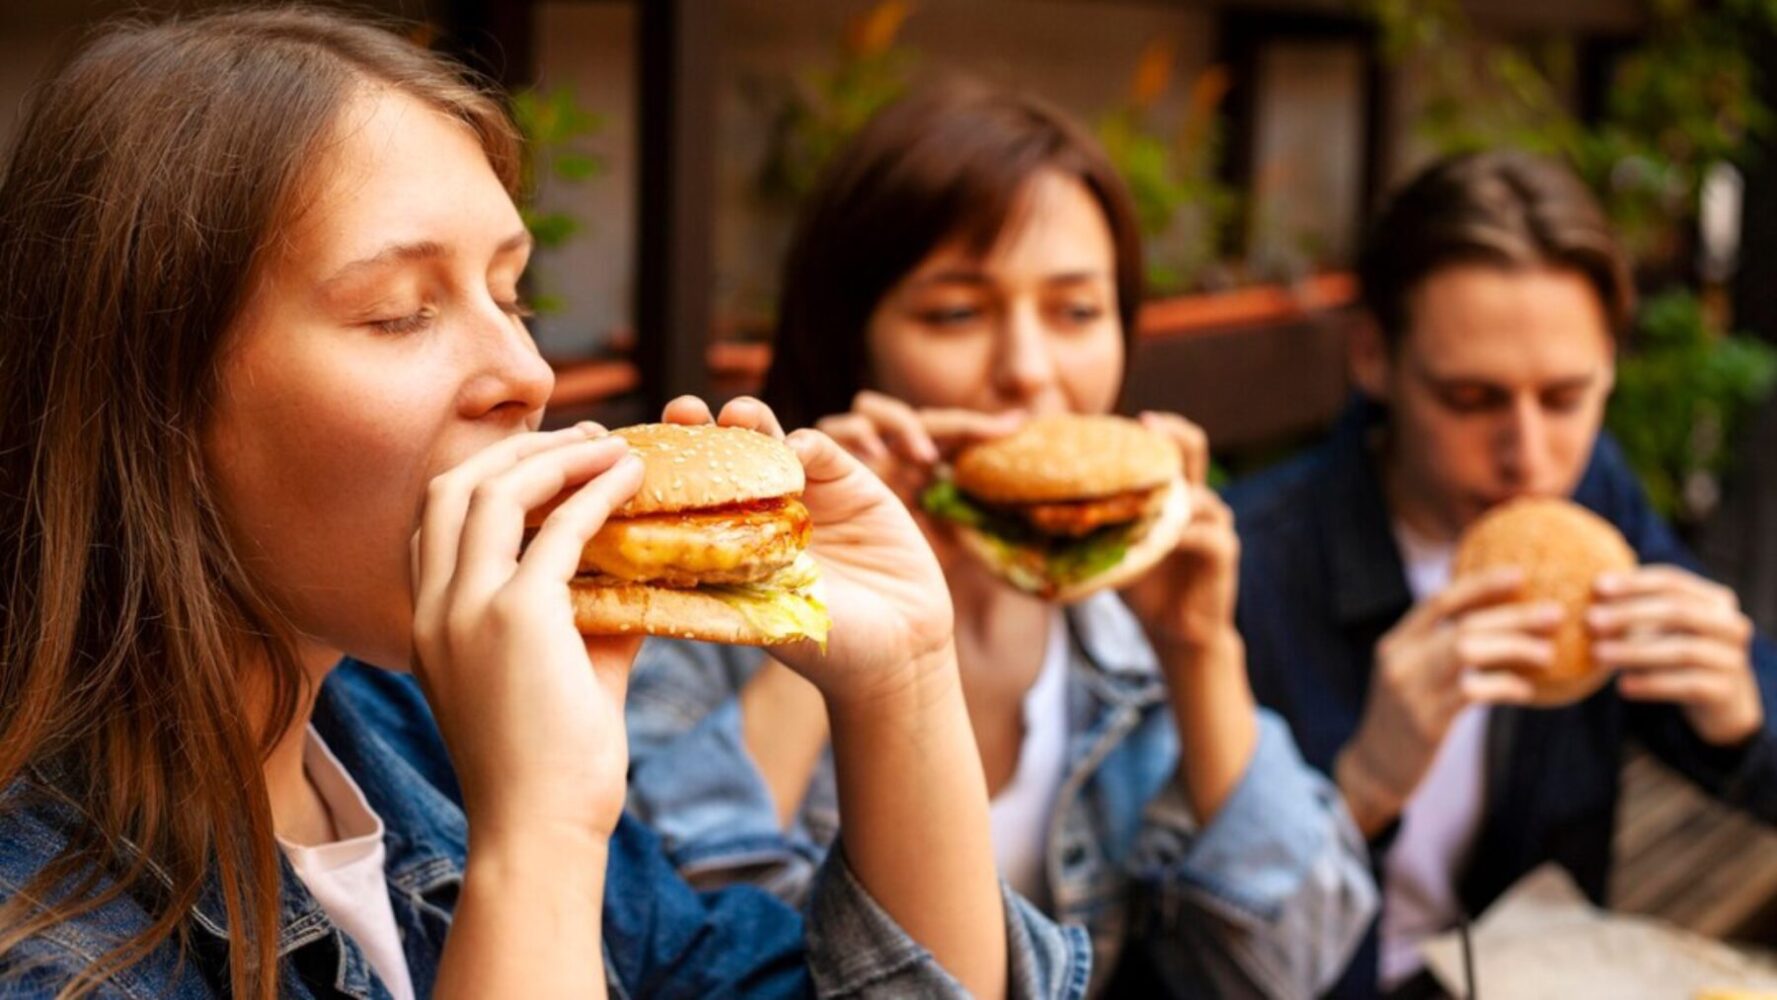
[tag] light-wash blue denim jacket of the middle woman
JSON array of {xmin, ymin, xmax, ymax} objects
[{"xmin": 629, "ymin": 595, "xmax": 1375, "ymax": 996}]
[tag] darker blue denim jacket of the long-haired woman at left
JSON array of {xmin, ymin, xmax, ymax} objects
[{"xmin": 0, "ymin": 661, "xmax": 1088, "ymax": 1000}]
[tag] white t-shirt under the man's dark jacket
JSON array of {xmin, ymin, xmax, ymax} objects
[{"xmin": 1381, "ymin": 524, "xmax": 1487, "ymax": 989}]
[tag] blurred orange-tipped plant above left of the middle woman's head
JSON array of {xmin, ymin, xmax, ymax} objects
[{"xmin": 759, "ymin": 0, "xmax": 919, "ymax": 204}]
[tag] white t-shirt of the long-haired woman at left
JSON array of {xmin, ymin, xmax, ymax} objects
[{"xmin": 277, "ymin": 726, "xmax": 414, "ymax": 1000}]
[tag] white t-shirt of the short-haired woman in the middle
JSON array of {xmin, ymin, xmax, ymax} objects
[{"xmin": 988, "ymin": 613, "xmax": 1070, "ymax": 906}]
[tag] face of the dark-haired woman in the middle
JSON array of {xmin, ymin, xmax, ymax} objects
[{"xmin": 869, "ymin": 171, "xmax": 1123, "ymax": 414}]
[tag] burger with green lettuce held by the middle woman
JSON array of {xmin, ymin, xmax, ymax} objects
[{"xmin": 920, "ymin": 414, "xmax": 1191, "ymax": 604}]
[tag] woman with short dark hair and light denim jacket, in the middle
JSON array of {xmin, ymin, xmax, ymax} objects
[{"xmin": 629, "ymin": 82, "xmax": 1375, "ymax": 996}]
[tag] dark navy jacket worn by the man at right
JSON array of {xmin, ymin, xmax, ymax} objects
[{"xmin": 1228, "ymin": 405, "xmax": 1777, "ymax": 996}]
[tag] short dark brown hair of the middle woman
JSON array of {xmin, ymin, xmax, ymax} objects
[{"xmin": 764, "ymin": 78, "xmax": 1143, "ymax": 426}]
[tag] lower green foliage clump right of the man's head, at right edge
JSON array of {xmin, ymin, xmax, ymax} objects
[{"xmin": 1606, "ymin": 291, "xmax": 1777, "ymax": 522}]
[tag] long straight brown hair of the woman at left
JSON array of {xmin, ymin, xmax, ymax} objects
[{"xmin": 0, "ymin": 9, "xmax": 517, "ymax": 996}]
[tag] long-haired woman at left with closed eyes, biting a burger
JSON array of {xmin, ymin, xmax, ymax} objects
[{"xmin": 0, "ymin": 9, "xmax": 1086, "ymax": 998}]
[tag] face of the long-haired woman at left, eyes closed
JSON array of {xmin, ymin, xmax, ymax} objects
[{"xmin": 204, "ymin": 89, "xmax": 554, "ymax": 668}]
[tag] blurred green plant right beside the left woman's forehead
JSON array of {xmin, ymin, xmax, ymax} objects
[{"xmin": 512, "ymin": 87, "xmax": 606, "ymax": 314}]
